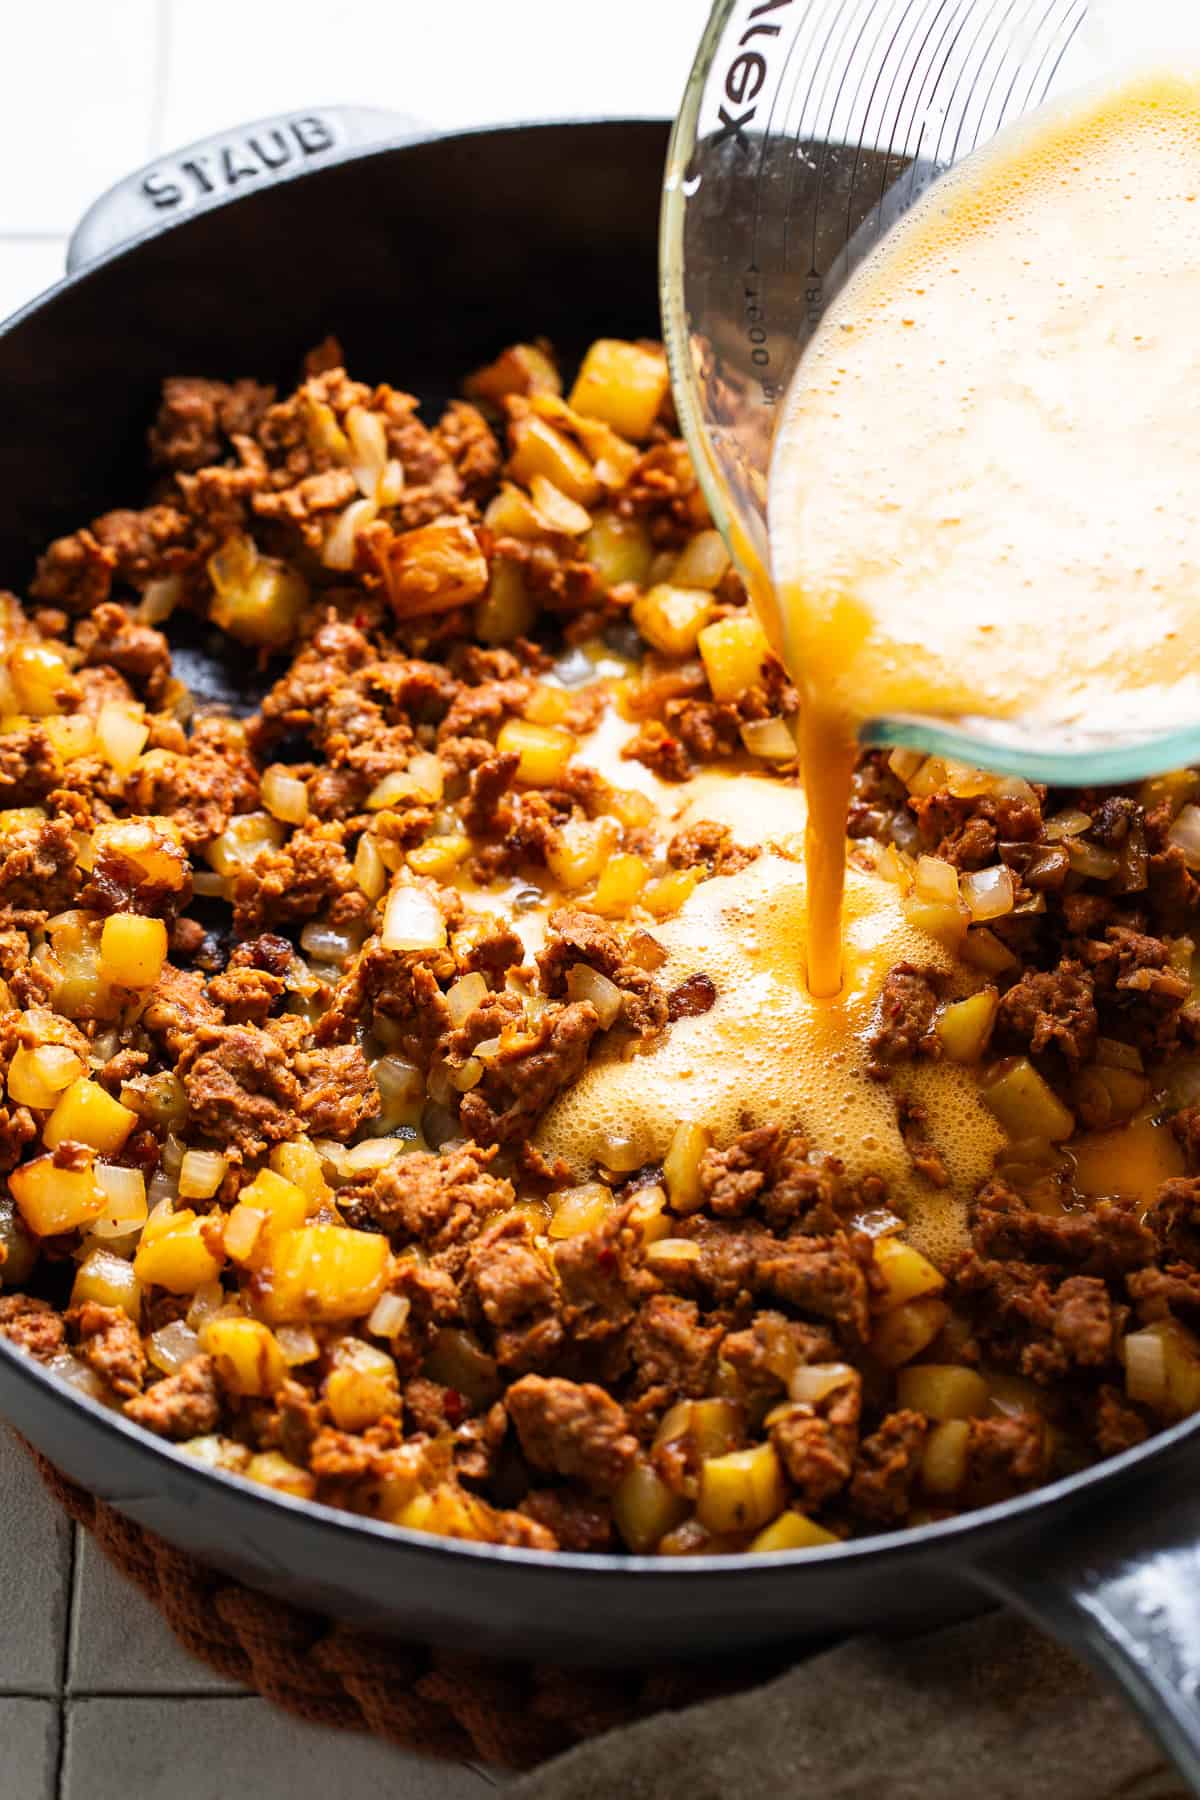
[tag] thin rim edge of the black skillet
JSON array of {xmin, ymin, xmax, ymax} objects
[{"xmin": 0, "ymin": 108, "xmax": 1200, "ymax": 1582}]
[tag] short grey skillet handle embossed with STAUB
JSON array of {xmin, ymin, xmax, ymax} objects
[{"xmin": 67, "ymin": 106, "xmax": 432, "ymax": 275}]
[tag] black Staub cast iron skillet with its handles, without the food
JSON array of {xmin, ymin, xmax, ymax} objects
[{"xmin": 0, "ymin": 110, "xmax": 1200, "ymax": 1791}]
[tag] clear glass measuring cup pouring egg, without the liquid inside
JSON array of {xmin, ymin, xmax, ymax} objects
[{"xmin": 660, "ymin": 0, "xmax": 1200, "ymax": 787}]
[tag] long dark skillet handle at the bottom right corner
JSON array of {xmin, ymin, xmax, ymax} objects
[{"xmin": 970, "ymin": 1483, "xmax": 1200, "ymax": 1795}]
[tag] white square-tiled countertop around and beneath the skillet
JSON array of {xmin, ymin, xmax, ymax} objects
[{"xmin": 0, "ymin": 0, "xmax": 707, "ymax": 1800}]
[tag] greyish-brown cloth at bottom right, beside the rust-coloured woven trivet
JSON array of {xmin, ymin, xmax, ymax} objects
[{"xmin": 507, "ymin": 1613, "xmax": 1187, "ymax": 1800}]
